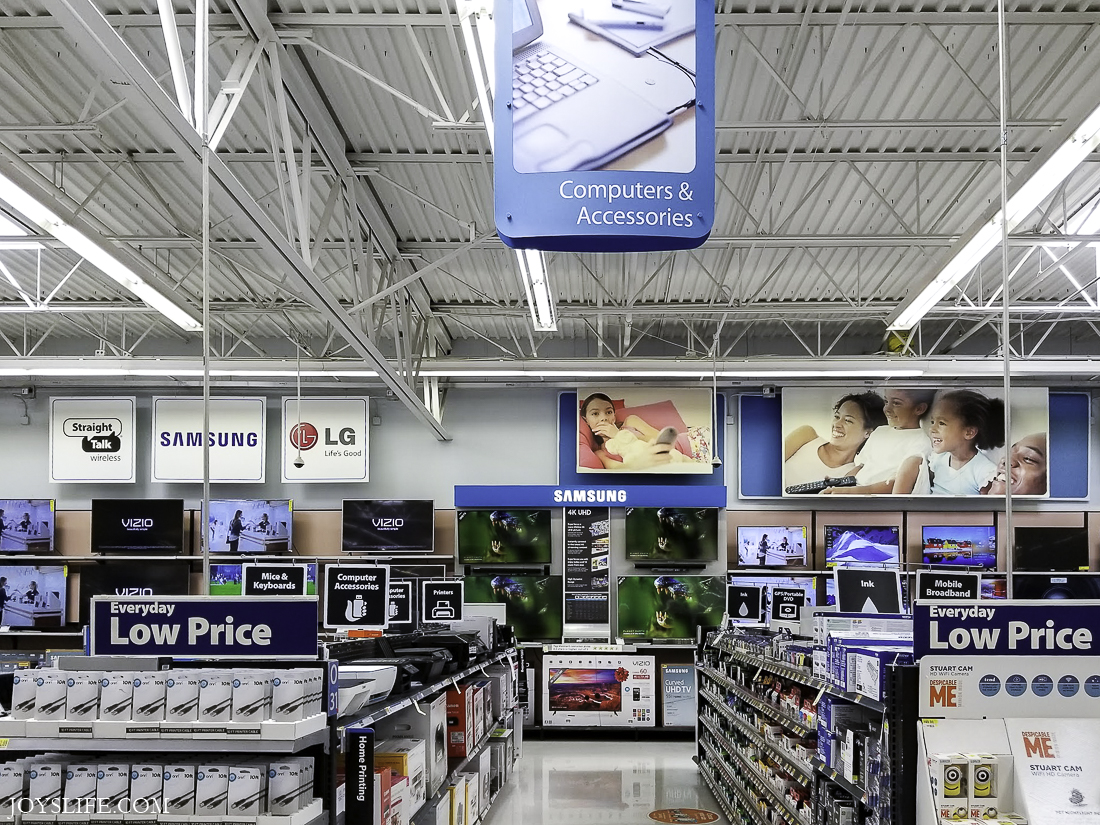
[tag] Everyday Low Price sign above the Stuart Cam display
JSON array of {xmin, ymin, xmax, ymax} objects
[{"xmin": 913, "ymin": 601, "xmax": 1100, "ymax": 657}]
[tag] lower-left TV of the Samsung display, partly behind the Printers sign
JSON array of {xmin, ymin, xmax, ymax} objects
[{"xmin": 462, "ymin": 573, "xmax": 563, "ymax": 641}]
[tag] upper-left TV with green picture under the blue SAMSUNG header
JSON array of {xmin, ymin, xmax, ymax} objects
[{"xmin": 457, "ymin": 507, "xmax": 553, "ymax": 564}]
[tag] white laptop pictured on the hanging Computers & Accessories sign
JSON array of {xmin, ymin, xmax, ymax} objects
[{"xmin": 512, "ymin": 0, "xmax": 672, "ymax": 173}]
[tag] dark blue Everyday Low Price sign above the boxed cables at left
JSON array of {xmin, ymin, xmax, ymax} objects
[{"xmin": 90, "ymin": 596, "xmax": 317, "ymax": 659}]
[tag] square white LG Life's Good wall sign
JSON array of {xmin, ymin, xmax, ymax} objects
[{"xmin": 282, "ymin": 397, "xmax": 369, "ymax": 483}]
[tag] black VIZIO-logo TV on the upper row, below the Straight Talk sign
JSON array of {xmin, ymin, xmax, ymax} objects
[{"xmin": 91, "ymin": 498, "xmax": 184, "ymax": 556}]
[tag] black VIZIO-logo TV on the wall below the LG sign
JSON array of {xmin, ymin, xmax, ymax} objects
[{"xmin": 340, "ymin": 499, "xmax": 436, "ymax": 554}]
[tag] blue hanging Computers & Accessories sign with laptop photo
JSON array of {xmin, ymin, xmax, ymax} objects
[{"xmin": 493, "ymin": 0, "xmax": 715, "ymax": 252}]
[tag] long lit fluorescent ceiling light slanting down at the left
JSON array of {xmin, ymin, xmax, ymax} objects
[{"xmin": 0, "ymin": 173, "xmax": 202, "ymax": 332}]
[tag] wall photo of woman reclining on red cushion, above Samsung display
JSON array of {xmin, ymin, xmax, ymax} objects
[{"xmin": 576, "ymin": 386, "xmax": 714, "ymax": 474}]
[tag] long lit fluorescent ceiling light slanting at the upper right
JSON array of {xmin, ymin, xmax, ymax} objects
[{"xmin": 887, "ymin": 97, "xmax": 1100, "ymax": 330}]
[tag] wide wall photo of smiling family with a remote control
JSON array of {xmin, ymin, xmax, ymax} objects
[{"xmin": 782, "ymin": 385, "xmax": 1049, "ymax": 497}]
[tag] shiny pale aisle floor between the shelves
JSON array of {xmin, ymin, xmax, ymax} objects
[{"xmin": 483, "ymin": 738, "xmax": 726, "ymax": 825}]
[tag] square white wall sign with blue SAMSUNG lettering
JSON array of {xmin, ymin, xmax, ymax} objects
[{"xmin": 152, "ymin": 397, "xmax": 267, "ymax": 483}]
